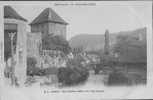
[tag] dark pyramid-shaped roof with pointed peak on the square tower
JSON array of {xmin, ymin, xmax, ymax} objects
[{"xmin": 30, "ymin": 8, "xmax": 68, "ymax": 25}]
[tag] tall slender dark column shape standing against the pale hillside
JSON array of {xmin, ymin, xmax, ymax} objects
[{"xmin": 104, "ymin": 30, "xmax": 109, "ymax": 55}]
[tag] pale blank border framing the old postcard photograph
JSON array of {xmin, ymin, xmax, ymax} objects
[{"xmin": 0, "ymin": 1, "xmax": 153, "ymax": 100}]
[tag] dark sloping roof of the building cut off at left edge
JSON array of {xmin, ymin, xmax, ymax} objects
[{"xmin": 4, "ymin": 6, "xmax": 27, "ymax": 21}]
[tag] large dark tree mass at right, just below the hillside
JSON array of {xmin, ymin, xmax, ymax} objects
[{"xmin": 114, "ymin": 35, "xmax": 146, "ymax": 63}]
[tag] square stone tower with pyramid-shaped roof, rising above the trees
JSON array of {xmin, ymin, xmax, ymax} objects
[{"xmin": 30, "ymin": 8, "xmax": 68, "ymax": 39}]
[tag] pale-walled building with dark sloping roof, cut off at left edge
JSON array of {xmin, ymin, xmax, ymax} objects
[{"xmin": 4, "ymin": 6, "xmax": 27, "ymax": 84}]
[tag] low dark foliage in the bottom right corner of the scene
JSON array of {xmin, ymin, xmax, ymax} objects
[{"xmin": 108, "ymin": 66, "xmax": 146, "ymax": 85}]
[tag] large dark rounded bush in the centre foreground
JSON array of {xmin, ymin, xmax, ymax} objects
[{"xmin": 58, "ymin": 65, "xmax": 89, "ymax": 85}]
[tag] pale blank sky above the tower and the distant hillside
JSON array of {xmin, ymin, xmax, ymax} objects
[{"xmin": 3, "ymin": 1, "xmax": 152, "ymax": 40}]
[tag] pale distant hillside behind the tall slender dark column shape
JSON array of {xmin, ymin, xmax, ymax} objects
[{"xmin": 69, "ymin": 28, "xmax": 146, "ymax": 51}]
